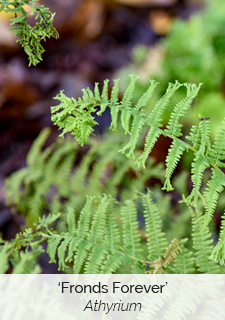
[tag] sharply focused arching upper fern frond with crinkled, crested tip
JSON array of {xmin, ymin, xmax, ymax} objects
[{"xmin": 52, "ymin": 75, "xmax": 225, "ymax": 261}]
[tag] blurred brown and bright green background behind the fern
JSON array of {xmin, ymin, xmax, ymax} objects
[{"xmin": 0, "ymin": 0, "xmax": 225, "ymax": 270}]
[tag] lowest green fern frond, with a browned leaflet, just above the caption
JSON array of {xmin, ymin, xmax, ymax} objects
[{"xmin": 2, "ymin": 192, "xmax": 220, "ymax": 274}]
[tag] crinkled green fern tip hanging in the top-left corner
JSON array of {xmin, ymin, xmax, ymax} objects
[{"xmin": 0, "ymin": 0, "xmax": 59, "ymax": 66}]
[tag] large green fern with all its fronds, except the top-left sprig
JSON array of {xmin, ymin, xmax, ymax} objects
[{"xmin": 2, "ymin": 75, "xmax": 225, "ymax": 273}]
